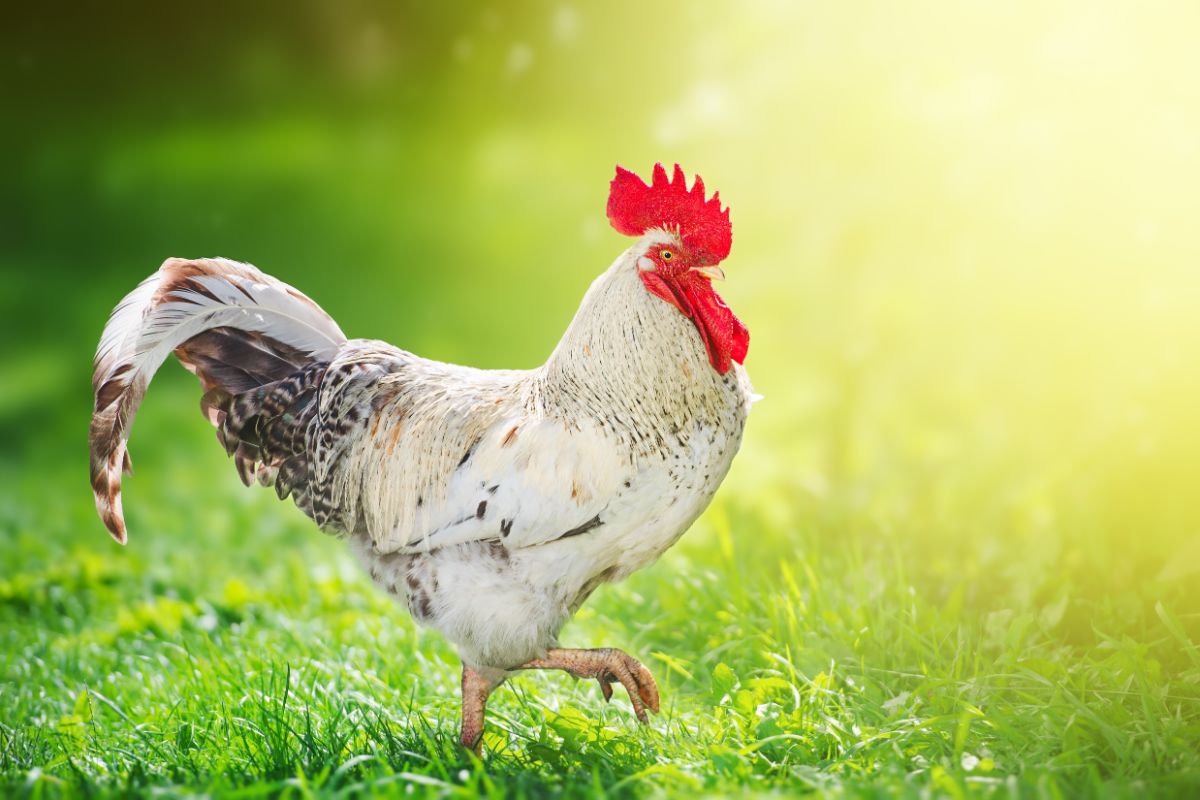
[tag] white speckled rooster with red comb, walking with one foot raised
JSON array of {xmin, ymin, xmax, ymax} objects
[{"xmin": 89, "ymin": 164, "xmax": 752, "ymax": 752}]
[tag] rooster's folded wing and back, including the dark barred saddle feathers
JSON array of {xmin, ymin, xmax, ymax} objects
[{"xmin": 210, "ymin": 339, "xmax": 629, "ymax": 553}]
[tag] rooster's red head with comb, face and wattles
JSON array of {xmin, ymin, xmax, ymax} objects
[{"xmin": 608, "ymin": 164, "xmax": 750, "ymax": 374}]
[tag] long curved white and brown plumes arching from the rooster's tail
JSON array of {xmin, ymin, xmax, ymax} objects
[{"xmin": 89, "ymin": 258, "xmax": 346, "ymax": 545}]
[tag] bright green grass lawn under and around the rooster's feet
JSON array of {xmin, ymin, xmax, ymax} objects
[{"xmin": 0, "ymin": 378, "xmax": 1200, "ymax": 796}]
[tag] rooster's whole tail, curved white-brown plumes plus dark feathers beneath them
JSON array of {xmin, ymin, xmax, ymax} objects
[{"xmin": 89, "ymin": 258, "xmax": 346, "ymax": 545}]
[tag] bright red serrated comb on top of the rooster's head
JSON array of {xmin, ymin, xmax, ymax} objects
[{"xmin": 608, "ymin": 164, "xmax": 733, "ymax": 264}]
